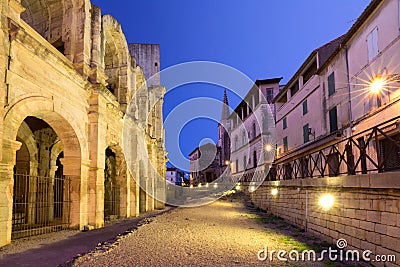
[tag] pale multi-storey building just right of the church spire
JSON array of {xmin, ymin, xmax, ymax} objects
[{"xmin": 229, "ymin": 78, "xmax": 282, "ymax": 181}]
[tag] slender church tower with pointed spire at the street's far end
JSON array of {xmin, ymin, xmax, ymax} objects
[{"xmin": 218, "ymin": 89, "xmax": 231, "ymax": 173}]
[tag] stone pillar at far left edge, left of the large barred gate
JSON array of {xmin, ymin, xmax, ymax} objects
[{"xmin": 0, "ymin": 139, "xmax": 21, "ymax": 247}]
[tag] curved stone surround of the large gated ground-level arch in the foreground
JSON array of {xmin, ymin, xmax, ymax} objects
[{"xmin": 3, "ymin": 96, "xmax": 88, "ymax": 230}]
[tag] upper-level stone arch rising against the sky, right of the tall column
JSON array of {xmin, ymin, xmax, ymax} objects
[{"xmin": 101, "ymin": 15, "xmax": 131, "ymax": 111}]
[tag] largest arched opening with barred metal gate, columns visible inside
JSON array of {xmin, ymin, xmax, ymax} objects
[{"xmin": 12, "ymin": 116, "xmax": 70, "ymax": 239}]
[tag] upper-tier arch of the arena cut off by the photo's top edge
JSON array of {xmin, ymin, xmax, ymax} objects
[{"xmin": 21, "ymin": 0, "xmax": 91, "ymax": 63}]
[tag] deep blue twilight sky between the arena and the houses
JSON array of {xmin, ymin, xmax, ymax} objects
[{"xmin": 92, "ymin": 0, "xmax": 370, "ymax": 172}]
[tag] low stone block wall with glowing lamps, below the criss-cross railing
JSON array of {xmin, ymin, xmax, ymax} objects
[{"xmin": 251, "ymin": 173, "xmax": 400, "ymax": 266}]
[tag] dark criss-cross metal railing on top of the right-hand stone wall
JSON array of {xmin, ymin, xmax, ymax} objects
[{"xmin": 267, "ymin": 116, "xmax": 400, "ymax": 180}]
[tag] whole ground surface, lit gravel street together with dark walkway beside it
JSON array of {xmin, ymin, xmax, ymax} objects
[{"xmin": 0, "ymin": 197, "xmax": 354, "ymax": 267}]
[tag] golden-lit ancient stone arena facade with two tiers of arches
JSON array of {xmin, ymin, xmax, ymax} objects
[{"xmin": 0, "ymin": 0, "xmax": 165, "ymax": 246}]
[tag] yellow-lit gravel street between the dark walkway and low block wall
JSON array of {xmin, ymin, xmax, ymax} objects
[{"xmin": 74, "ymin": 195, "xmax": 338, "ymax": 266}]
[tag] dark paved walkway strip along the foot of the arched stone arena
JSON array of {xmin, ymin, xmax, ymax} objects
[{"xmin": 0, "ymin": 208, "xmax": 170, "ymax": 267}]
